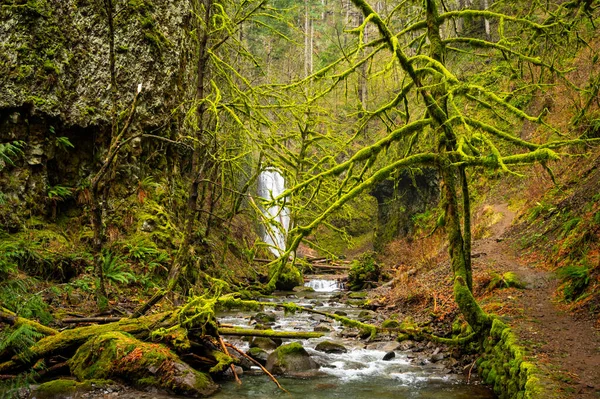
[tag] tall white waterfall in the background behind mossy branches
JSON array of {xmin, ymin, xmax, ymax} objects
[{"xmin": 258, "ymin": 169, "xmax": 290, "ymax": 256}]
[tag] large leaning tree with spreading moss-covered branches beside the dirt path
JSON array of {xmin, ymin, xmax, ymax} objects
[{"xmin": 269, "ymin": 0, "xmax": 596, "ymax": 333}]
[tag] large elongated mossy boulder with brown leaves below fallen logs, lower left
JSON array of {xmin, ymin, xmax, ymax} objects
[{"xmin": 69, "ymin": 332, "xmax": 219, "ymax": 396}]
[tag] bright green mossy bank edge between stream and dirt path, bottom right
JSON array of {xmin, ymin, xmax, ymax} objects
[{"xmin": 477, "ymin": 319, "xmax": 551, "ymax": 399}]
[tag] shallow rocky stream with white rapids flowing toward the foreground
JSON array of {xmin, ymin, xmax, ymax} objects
[{"xmin": 213, "ymin": 280, "xmax": 494, "ymax": 399}]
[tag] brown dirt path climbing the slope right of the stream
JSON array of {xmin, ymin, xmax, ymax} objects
[{"xmin": 473, "ymin": 204, "xmax": 600, "ymax": 399}]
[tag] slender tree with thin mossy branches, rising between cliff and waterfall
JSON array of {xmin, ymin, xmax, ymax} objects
[{"xmin": 135, "ymin": 0, "xmax": 277, "ymax": 317}]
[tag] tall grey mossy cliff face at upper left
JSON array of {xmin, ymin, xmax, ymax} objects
[{"xmin": 0, "ymin": 0, "xmax": 193, "ymax": 232}]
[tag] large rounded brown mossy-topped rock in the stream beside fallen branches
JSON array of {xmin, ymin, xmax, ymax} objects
[{"xmin": 265, "ymin": 342, "xmax": 319, "ymax": 375}]
